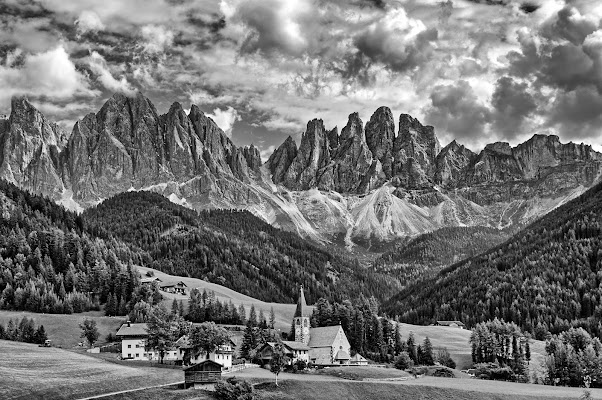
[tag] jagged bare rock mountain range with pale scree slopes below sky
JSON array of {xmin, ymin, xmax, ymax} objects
[{"xmin": 0, "ymin": 93, "xmax": 602, "ymax": 246}]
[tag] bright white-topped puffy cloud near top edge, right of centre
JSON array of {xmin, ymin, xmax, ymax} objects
[{"xmin": 354, "ymin": 8, "xmax": 438, "ymax": 71}]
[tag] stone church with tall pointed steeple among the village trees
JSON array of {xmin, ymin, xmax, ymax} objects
[{"xmin": 293, "ymin": 286, "xmax": 351, "ymax": 365}]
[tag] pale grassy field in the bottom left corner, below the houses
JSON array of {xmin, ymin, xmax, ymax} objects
[{"xmin": 0, "ymin": 340, "xmax": 184, "ymax": 400}]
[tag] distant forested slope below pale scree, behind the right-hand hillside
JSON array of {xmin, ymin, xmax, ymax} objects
[{"xmin": 372, "ymin": 226, "xmax": 511, "ymax": 285}]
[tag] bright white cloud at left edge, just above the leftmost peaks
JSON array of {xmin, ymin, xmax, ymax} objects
[{"xmin": 0, "ymin": 46, "xmax": 99, "ymax": 107}]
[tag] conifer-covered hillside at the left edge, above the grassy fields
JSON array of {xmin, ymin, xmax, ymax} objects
[{"xmin": 0, "ymin": 180, "xmax": 141, "ymax": 315}]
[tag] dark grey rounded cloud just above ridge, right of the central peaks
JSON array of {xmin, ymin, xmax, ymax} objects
[{"xmin": 425, "ymin": 80, "xmax": 492, "ymax": 141}]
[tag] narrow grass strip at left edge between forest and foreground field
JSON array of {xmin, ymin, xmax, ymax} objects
[{"xmin": 0, "ymin": 311, "xmax": 126, "ymax": 349}]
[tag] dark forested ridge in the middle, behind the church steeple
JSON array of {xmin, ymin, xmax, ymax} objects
[{"xmin": 83, "ymin": 192, "xmax": 399, "ymax": 302}]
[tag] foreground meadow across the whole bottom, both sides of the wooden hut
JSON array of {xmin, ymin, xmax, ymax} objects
[{"xmin": 0, "ymin": 341, "xmax": 602, "ymax": 400}]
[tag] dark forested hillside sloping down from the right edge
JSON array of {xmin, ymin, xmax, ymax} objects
[{"xmin": 383, "ymin": 184, "xmax": 602, "ymax": 339}]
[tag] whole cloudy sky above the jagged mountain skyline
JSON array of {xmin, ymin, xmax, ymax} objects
[{"xmin": 0, "ymin": 0, "xmax": 602, "ymax": 159}]
